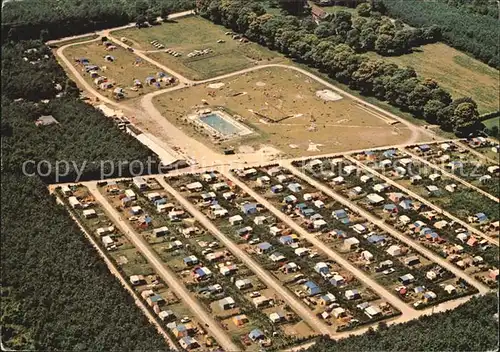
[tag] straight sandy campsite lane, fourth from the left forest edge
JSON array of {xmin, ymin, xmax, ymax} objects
[{"xmin": 224, "ymin": 172, "xmax": 417, "ymax": 316}]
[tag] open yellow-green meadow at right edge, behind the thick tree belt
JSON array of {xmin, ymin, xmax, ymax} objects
[{"xmin": 366, "ymin": 43, "xmax": 499, "ymax": 114}]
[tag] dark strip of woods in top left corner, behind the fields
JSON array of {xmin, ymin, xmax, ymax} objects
[{"xmin": 2, "ymin": 0, "xmax": 195, "ymax": 41}]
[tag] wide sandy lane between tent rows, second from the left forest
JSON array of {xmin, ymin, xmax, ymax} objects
[{"xmin": 87, "ymin": 182, "xmax": 239, "ymax": 351}]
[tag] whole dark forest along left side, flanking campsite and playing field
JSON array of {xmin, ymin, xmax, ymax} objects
[{"xmin": 0, "ymin": 37, "xmax": 166, "ymax": 351}]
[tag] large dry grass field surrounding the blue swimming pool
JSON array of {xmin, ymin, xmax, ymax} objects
[{"xmin": 154, "ymin": 68, "xmax": 409, "ymax": 155}]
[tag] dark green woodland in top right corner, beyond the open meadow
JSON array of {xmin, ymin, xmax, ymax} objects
[{"xmin": 378, "ymin": 0, "xmax": 500, "ymax": 68}]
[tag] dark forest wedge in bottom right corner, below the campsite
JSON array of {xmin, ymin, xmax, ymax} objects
[{"xmin": 306, "ymin": 294, "xmax": 499, "ymax": 352}]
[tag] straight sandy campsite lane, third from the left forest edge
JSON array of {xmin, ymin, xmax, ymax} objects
[{"xmin": 156, "ymin": 177, "xmax": 335, "ymax": 336}]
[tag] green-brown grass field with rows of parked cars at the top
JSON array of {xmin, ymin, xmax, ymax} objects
[{"xmin": 112, "ymin": 16, "xmax": 284, "ymax": 80}]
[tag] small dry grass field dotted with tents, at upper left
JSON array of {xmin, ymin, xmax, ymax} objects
[{"xmin": 64, "ymin": 41, "xmax": 176, "ymax": 98}]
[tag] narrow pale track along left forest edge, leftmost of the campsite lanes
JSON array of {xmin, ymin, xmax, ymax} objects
[{"xmin": 49, "ymin": 195, "xmax": 178, "ymax": 351}]
